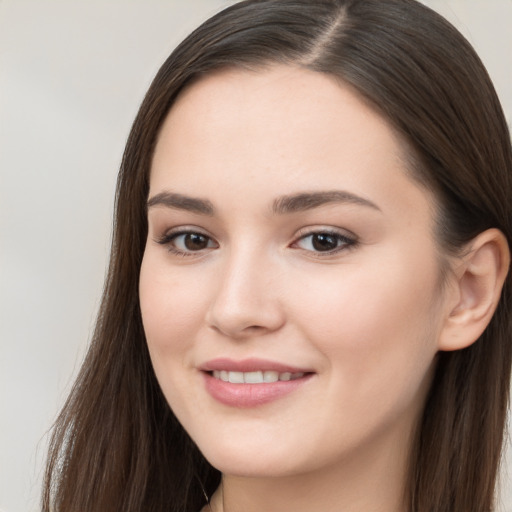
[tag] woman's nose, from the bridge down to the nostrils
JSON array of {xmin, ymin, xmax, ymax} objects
[{"xmin": 206, "ymin": 251, "xmax": 285, "ymax": 339}]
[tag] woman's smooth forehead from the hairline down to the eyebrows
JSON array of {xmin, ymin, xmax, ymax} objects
[{"xmin": 150, "ymin": 66, "xmax": 434, "ymax": 222}]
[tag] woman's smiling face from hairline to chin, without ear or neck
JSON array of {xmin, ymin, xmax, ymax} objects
[{"xmin": 140, "ymin": 66, "xmax": 444, "ymax": 475}]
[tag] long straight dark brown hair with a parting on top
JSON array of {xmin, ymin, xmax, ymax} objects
[{"xmin": 43, "ymin": 0, "xmax": 512, "ymax": 512}]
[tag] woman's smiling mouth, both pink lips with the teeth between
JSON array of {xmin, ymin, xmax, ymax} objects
[{"xmin": 200, "ymin": 359, "xmax": 314, "ymax": 408}]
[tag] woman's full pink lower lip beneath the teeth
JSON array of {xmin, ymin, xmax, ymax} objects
[{"xmin": 203, "ymin": 372, "xmax": 312, "ymax": 408}]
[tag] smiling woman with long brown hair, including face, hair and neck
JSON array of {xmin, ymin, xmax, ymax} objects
[{"xmin": 43, "ymin": 0, "xmax": 512, "ymax": 512}]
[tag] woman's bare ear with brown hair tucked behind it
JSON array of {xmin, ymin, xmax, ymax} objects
[{"xmin": 438, "ymin": 229, "xmax": 510, "ymax": 351}]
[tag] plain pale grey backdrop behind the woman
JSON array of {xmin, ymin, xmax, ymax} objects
[{"xmin": 0, "ymin": 0, "xmax": 512, "ymax": 512}]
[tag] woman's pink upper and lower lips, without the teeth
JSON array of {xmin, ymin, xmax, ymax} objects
[{"xmin": 200, "ymin": 358, "xmax": 313, "ymax": 408}]
